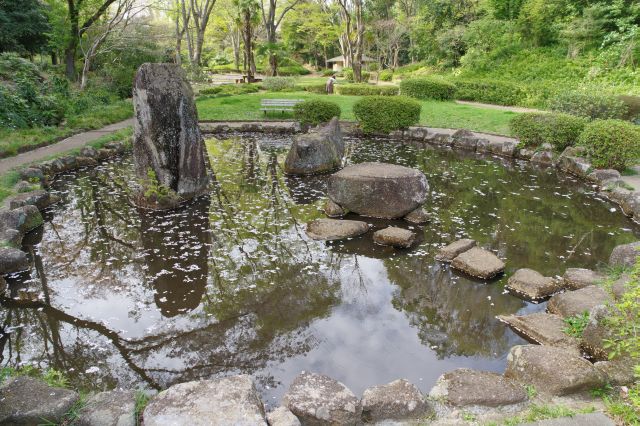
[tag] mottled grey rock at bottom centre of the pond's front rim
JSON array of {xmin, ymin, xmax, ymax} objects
[{"xmin": 282, "ymin": 372, "xmax": 362, "ymax": 425}]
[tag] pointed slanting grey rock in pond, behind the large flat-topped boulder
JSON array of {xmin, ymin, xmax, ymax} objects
[{"xmin": 284, "ymin": 117, "xmax": 344, "ymax": 175}]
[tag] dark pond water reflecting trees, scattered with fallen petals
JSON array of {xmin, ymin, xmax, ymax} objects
[{"xmin": 0, "ymin": 135, "xmax": 640, "ymax": 404}]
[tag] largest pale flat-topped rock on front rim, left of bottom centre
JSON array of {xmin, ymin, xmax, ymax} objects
[{"xmin": 143, "ymin": 375, "xmax": 267, "ymax": 426}]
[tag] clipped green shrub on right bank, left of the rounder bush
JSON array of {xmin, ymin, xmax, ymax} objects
[{"xmin": 509, "ymin": 113, "xmax": 587, "ymax": 151}]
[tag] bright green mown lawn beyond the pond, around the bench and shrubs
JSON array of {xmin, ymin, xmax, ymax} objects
[{"xmin": 197, "ymin": 92, "xmax": 517, "ymax": 135}]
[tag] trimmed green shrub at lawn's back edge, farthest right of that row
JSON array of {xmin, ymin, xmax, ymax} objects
[{"xmin": 455, "ymin": 80, "xmax": 526, "ymax": 105}]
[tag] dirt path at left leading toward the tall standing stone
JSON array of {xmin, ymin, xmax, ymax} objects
[{"xmin": 0, "ymin": 118, "xmax": 133, "ymax": 174}]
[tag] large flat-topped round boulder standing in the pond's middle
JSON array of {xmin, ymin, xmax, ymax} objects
[{"xmin": 328, "ymin": 163, "xmax": 429, "ymax": 219}]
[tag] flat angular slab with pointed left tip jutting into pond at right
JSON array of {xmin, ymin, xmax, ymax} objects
[{"xmin": 497, "ymin": 312, "xmax": 580, "ymax": 356}]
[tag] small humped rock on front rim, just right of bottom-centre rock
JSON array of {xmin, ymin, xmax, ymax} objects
[{"xmin": 362, "ymin": 379, "xmax": 433, "ymax": 422}]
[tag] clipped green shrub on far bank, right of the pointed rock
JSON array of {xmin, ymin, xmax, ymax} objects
[{"xmin": 353, "ymin": 96, "xmax": 420, "ymax": 134}]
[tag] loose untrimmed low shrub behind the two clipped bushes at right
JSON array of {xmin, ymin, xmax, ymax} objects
[{"xmin": 549, "ymin": 92, "xmax": 627, "ymax": 120}]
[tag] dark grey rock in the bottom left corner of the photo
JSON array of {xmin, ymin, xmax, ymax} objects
[{"xmin": 0, "ymin": 376, "xmax": 80, "ymax": 425}]
